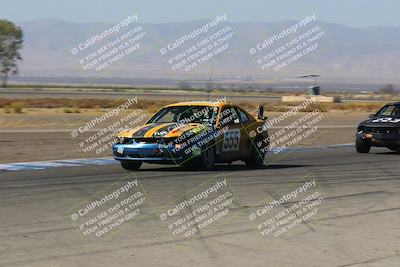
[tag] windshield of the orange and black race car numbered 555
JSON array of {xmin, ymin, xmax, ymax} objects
[{"xmin": 149, "ymin": 106, "xmax": 218, "ymax": 123}]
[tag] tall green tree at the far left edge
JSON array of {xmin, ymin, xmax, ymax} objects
[{"xmin": 0, "ymin": 20, "xmax": 23, "ymax": 88}]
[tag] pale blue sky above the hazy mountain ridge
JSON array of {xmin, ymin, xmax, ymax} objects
[{"xmin": 0, "ymin": 0, "xmax": 400, "ymax": 27}]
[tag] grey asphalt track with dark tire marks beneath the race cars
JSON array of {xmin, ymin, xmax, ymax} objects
[{"xmin": 0, "ymin": 145, "xmax": 400, "ymax": 266}]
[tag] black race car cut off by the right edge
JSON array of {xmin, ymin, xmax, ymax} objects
[{"xmin": 356, "ymin": 102, "xmax": 400, "ymax": 153}]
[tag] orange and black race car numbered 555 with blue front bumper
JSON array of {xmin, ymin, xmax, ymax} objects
[{"xmin": 112, "ymin": 101, "xmax": 268, "ymax": 170}]
